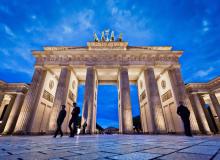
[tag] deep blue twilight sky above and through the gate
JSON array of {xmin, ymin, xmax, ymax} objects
[{"xmin": 0, "ymin": 0, "xmax": 220, "ymax": 125}]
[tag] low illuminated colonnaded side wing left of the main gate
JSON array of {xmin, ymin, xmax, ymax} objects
[{"xmin": 0, "ymin": 81, "xmax": 29, "ymax": 134}]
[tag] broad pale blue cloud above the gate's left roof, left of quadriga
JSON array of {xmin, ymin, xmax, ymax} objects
[{"xmin": 26, "ymin": 9, "xmax": 95, "ymax": 45}]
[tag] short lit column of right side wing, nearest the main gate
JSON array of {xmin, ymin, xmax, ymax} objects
[{"xmin": 190, "ymin": 94, "xmax": 210, "ymax": 134}]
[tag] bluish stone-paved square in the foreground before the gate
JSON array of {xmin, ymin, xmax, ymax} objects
[{"xmin": 0, "ymin": 135, "xmax": 220, "ymax": 160}]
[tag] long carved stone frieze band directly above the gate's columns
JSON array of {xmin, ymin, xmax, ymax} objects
[{"xmin": 36, "ymin": 54, "xmax": 179, "ymax": 66}]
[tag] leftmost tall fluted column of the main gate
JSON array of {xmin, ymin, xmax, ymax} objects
[{"xmin": 14, "ymin": 67, "xmax": 46, "ymax": 134}]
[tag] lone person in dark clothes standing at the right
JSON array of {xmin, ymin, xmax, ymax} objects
[{"xmin": 177, "ymin": 101, "xmax": 192, "ymax": 137}]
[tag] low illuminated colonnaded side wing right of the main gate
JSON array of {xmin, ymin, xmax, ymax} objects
[{"xmin": 186, "ymin": 77, "xmax": 220, "ymax": 134}]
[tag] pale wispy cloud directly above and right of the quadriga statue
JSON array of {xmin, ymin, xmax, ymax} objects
[{"xmin": 107, "ymin": 0, "xmax": 153, "ymax": 45}]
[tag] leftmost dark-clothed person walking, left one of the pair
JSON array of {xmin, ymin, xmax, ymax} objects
[{"xmin": 54, "ymin": 105, "xmax": 66, "ymax": 138}]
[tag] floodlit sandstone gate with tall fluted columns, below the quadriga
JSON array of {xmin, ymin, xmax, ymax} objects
[{"xmin": 0, "ymin": 42, "xmax": 220, "ymax": 134}]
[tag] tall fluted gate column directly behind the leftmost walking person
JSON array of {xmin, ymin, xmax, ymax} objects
[{"xmin": 49, "ymin": 66, "xmax": 71, "ymax": 132}]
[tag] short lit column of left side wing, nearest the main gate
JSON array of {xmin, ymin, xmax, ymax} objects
[{"xmin": 3, "ymin": 93, "xmax": 24, "ymax": 134}]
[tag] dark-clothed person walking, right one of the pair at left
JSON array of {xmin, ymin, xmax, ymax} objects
[{"xmin": 69, "ymin": 102, "xmax": 80, "ymax": 137}]
